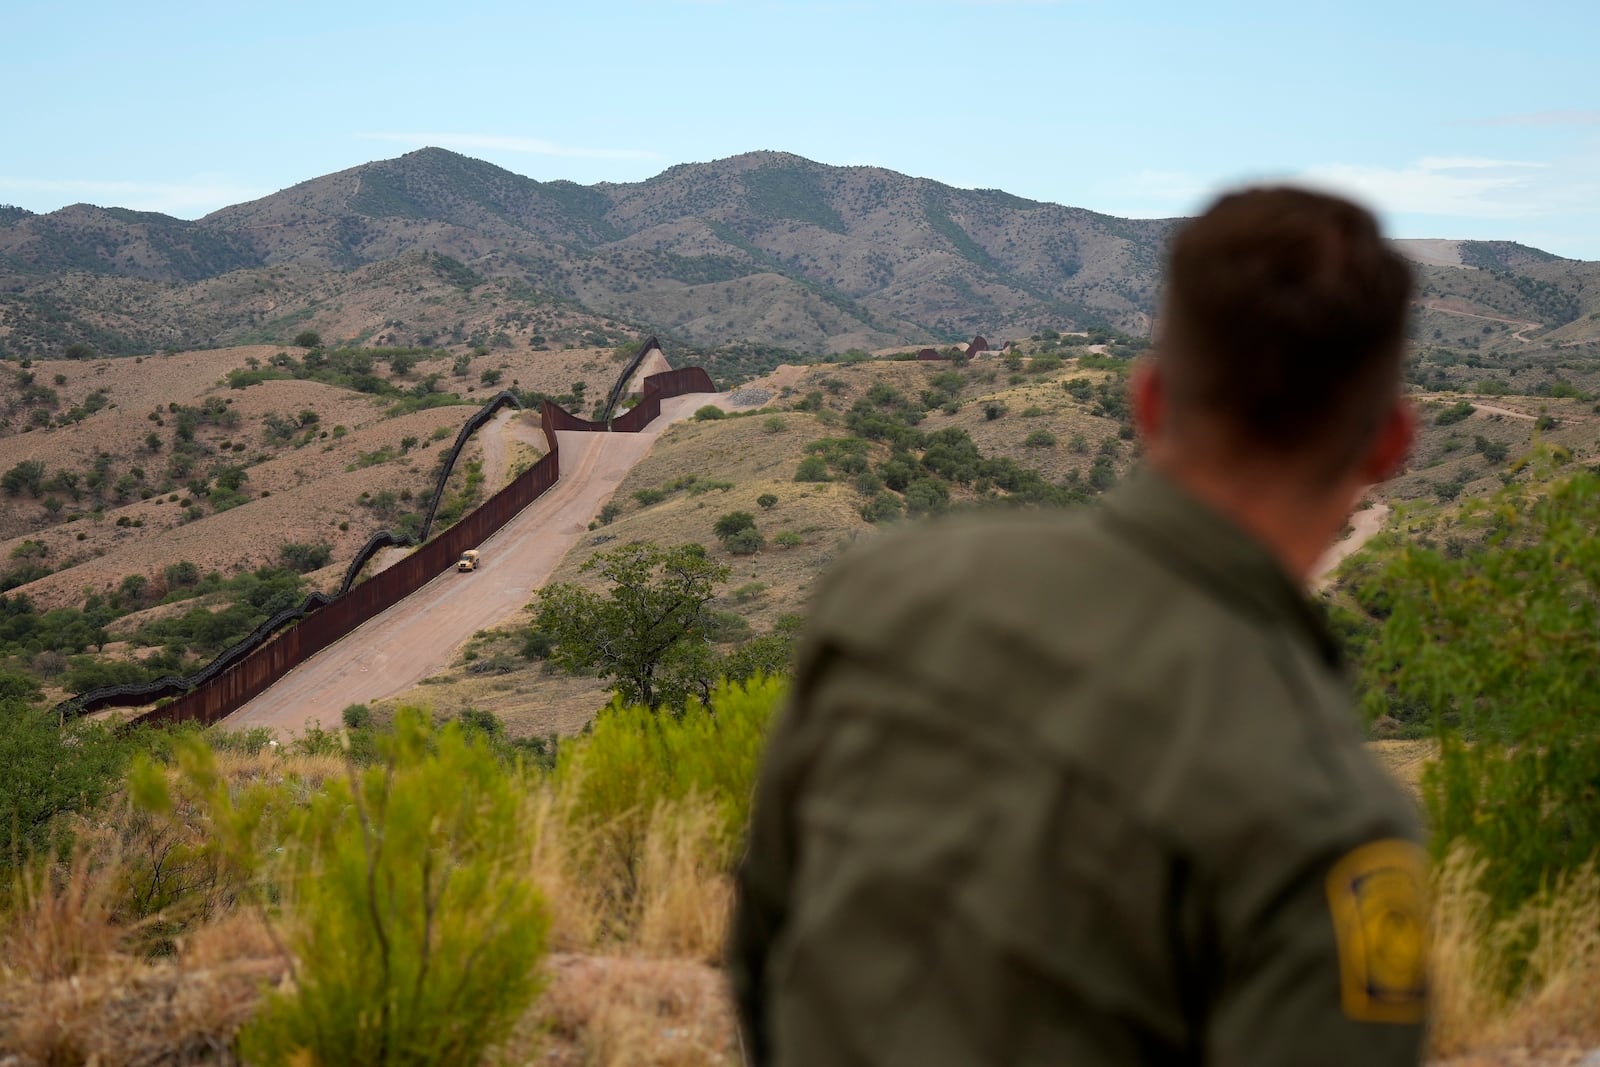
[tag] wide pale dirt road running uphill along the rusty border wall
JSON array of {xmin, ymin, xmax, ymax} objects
[{"xmin": 222, "ymin": 394, "xmax": 731, "ymax": 733}]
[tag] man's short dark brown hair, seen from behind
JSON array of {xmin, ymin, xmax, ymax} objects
[{"xmin": 1158, "ymin": 189, "xmax": 1411, "ymax": 472}]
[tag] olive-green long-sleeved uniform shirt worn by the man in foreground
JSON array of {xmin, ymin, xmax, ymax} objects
[{"xmin": 730, "ymin": 475, "xmax": 1426, "ymax": 1067}]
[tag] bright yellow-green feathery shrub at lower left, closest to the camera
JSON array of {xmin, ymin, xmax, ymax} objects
[{"xmin": 240, "ymin": 709, "xmax": 549, "ymax": 1065}]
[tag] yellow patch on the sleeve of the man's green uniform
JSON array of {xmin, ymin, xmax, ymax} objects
[{"xmin": 1328, "ymin": 838, "xmax": 1427, "ymax": 1024}]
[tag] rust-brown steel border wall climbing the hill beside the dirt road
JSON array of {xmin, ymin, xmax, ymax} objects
[{"xmin": 104, "ymin": 366, "xmax": 715, "ymax": 735}]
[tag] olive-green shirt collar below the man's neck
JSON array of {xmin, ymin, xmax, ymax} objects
[{"xmin": 1102, "ymin": 470, "xmax": 1342, "ymax": 669}]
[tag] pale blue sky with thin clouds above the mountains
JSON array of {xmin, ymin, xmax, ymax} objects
[{"xmin": 9, "ymin": 0, "xmax": 1600, "ymax": 259}]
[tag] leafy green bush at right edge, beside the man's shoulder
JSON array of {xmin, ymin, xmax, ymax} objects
[{"xmin": 1365, "ymin": 472, "xmax": 1600, "ymax": 913}]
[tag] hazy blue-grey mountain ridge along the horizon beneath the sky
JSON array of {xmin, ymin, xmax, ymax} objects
[{"xmin": 0, "ymin": 147, "xmax": 1592, "ymax": 352}]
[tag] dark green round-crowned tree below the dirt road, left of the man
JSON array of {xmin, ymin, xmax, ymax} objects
[{"xmin": 533, "ymin": 541, "xmax": 731, "ymax": 710}]
